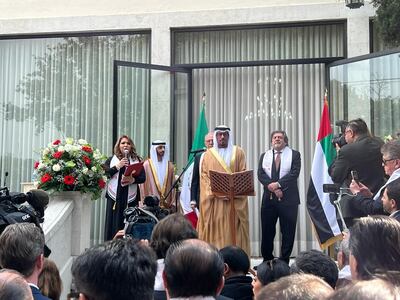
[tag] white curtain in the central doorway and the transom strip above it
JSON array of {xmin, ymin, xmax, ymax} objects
[{"xmin": 175, "ymin": 24, "xmax": 344, "ymax": 256}]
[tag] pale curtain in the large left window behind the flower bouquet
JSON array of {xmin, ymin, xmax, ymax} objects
[{"xmin": 0, "ymin": 34, "xmax": 150, "ymax": 243}]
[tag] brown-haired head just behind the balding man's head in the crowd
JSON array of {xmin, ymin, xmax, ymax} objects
[{"xmin": 150, "ymin": 213, "xmax": 197, "ymax": 258}]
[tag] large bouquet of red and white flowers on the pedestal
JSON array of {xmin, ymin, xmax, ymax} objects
[{"xmin": 34, "ymin": 138, "xmax": 107, "ymax": 200}]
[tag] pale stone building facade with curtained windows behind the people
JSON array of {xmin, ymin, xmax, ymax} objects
[{"xmin": 0, "ymin": 0, "xmax": 398, "ymax": 255}]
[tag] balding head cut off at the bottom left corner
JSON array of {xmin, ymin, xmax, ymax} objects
[{"xmin": 0, "ymin": 269, "xmax": 33, "ymax": 300}]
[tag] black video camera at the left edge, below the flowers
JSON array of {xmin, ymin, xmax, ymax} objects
[{"xmin": 0, "ymin": 187, "xmax": 49, "ymax": 234}]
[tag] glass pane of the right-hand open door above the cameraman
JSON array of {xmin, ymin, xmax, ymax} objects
[{"xmin": 329, "ymin": 53, "xmax": 400, "ymax": 138}]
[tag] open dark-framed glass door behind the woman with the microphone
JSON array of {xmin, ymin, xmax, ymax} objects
[{"xmin": 112, "ymin": 61, "xmax": 191, "ymax": 162}]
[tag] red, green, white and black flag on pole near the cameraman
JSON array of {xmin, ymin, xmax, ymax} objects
[{"xmin": 307, "ymin": 93, "xmax": 342, "ymax": 249}]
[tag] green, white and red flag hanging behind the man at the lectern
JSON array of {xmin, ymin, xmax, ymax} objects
[{"xmin": 180, "ymin": 96, "xmax": 208, "ymax": 228}]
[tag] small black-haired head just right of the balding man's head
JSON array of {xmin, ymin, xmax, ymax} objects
[{"xmin": 219, "ymin": 246, "xmax": 250, "ymax": 278}]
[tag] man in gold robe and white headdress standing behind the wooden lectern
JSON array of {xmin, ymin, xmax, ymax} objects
[{"xmin": 197, "ymin": 125, "xmax": 250, "ymax": 256}]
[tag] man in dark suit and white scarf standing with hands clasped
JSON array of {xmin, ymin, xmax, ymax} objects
[{"xmin": 258, "ymin": 131, "xmax": 301, "ymax": 263}]
